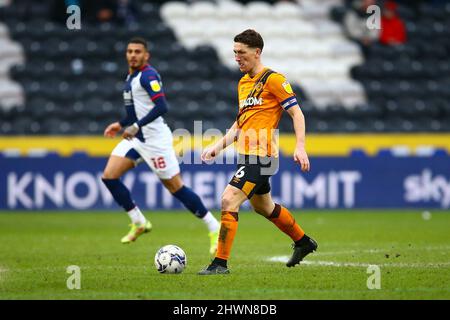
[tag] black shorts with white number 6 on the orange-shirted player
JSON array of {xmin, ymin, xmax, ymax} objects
[{"xmin": 229, "ymin": 156, "xmax": 278, "ymax": 199}]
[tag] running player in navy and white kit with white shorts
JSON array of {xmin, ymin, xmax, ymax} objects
[{"xmin": 102, "ymin": 38, "xmax": 220, "ymax": 254}]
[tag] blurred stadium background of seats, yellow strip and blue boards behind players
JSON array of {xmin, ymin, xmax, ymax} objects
[{"xmin": 0, "ymin": 0, "xmax": 450, "ymax": 210}]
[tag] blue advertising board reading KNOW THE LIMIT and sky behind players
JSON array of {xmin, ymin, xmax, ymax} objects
[{"xmin": 0, "ymin": 153, "xmax": 450, "ymax": 210}]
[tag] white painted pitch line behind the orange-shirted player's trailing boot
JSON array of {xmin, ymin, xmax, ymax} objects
[{"xmin": 266, "ymin": 256, "xmax": 450, "ymax": 268}]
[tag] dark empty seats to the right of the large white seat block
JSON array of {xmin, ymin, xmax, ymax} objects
[{"xmin": 342, "ymin": 0, "xmax": 450, "ymax": 131}]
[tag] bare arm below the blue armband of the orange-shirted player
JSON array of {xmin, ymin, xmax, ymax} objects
[{"xmin": 287, "ymin": 104, "xmax": 310, "ymax": 171}]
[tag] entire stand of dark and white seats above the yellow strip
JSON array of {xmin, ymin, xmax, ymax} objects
[{"xmin": 0, "ymin": 0, "xmax": 450, "ymax": 134}]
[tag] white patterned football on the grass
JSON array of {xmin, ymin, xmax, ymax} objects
[{"xmin": 155, "ymin": 244, "xmax": 187, "ymax": 273}]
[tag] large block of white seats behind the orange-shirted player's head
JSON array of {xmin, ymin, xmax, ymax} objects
[{"xmin": 161, "ymin": 0, "xmax": 366, "ymax": 108}]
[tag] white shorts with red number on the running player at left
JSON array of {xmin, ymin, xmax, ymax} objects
[{"xmin": 111, "ymin": 138, "xmax": 180, "ymax": 180}]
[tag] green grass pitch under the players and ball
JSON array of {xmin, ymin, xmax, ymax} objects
[{"xmin": 0, "ymin": 210, "xmax": 450, "ymax": 300}]
